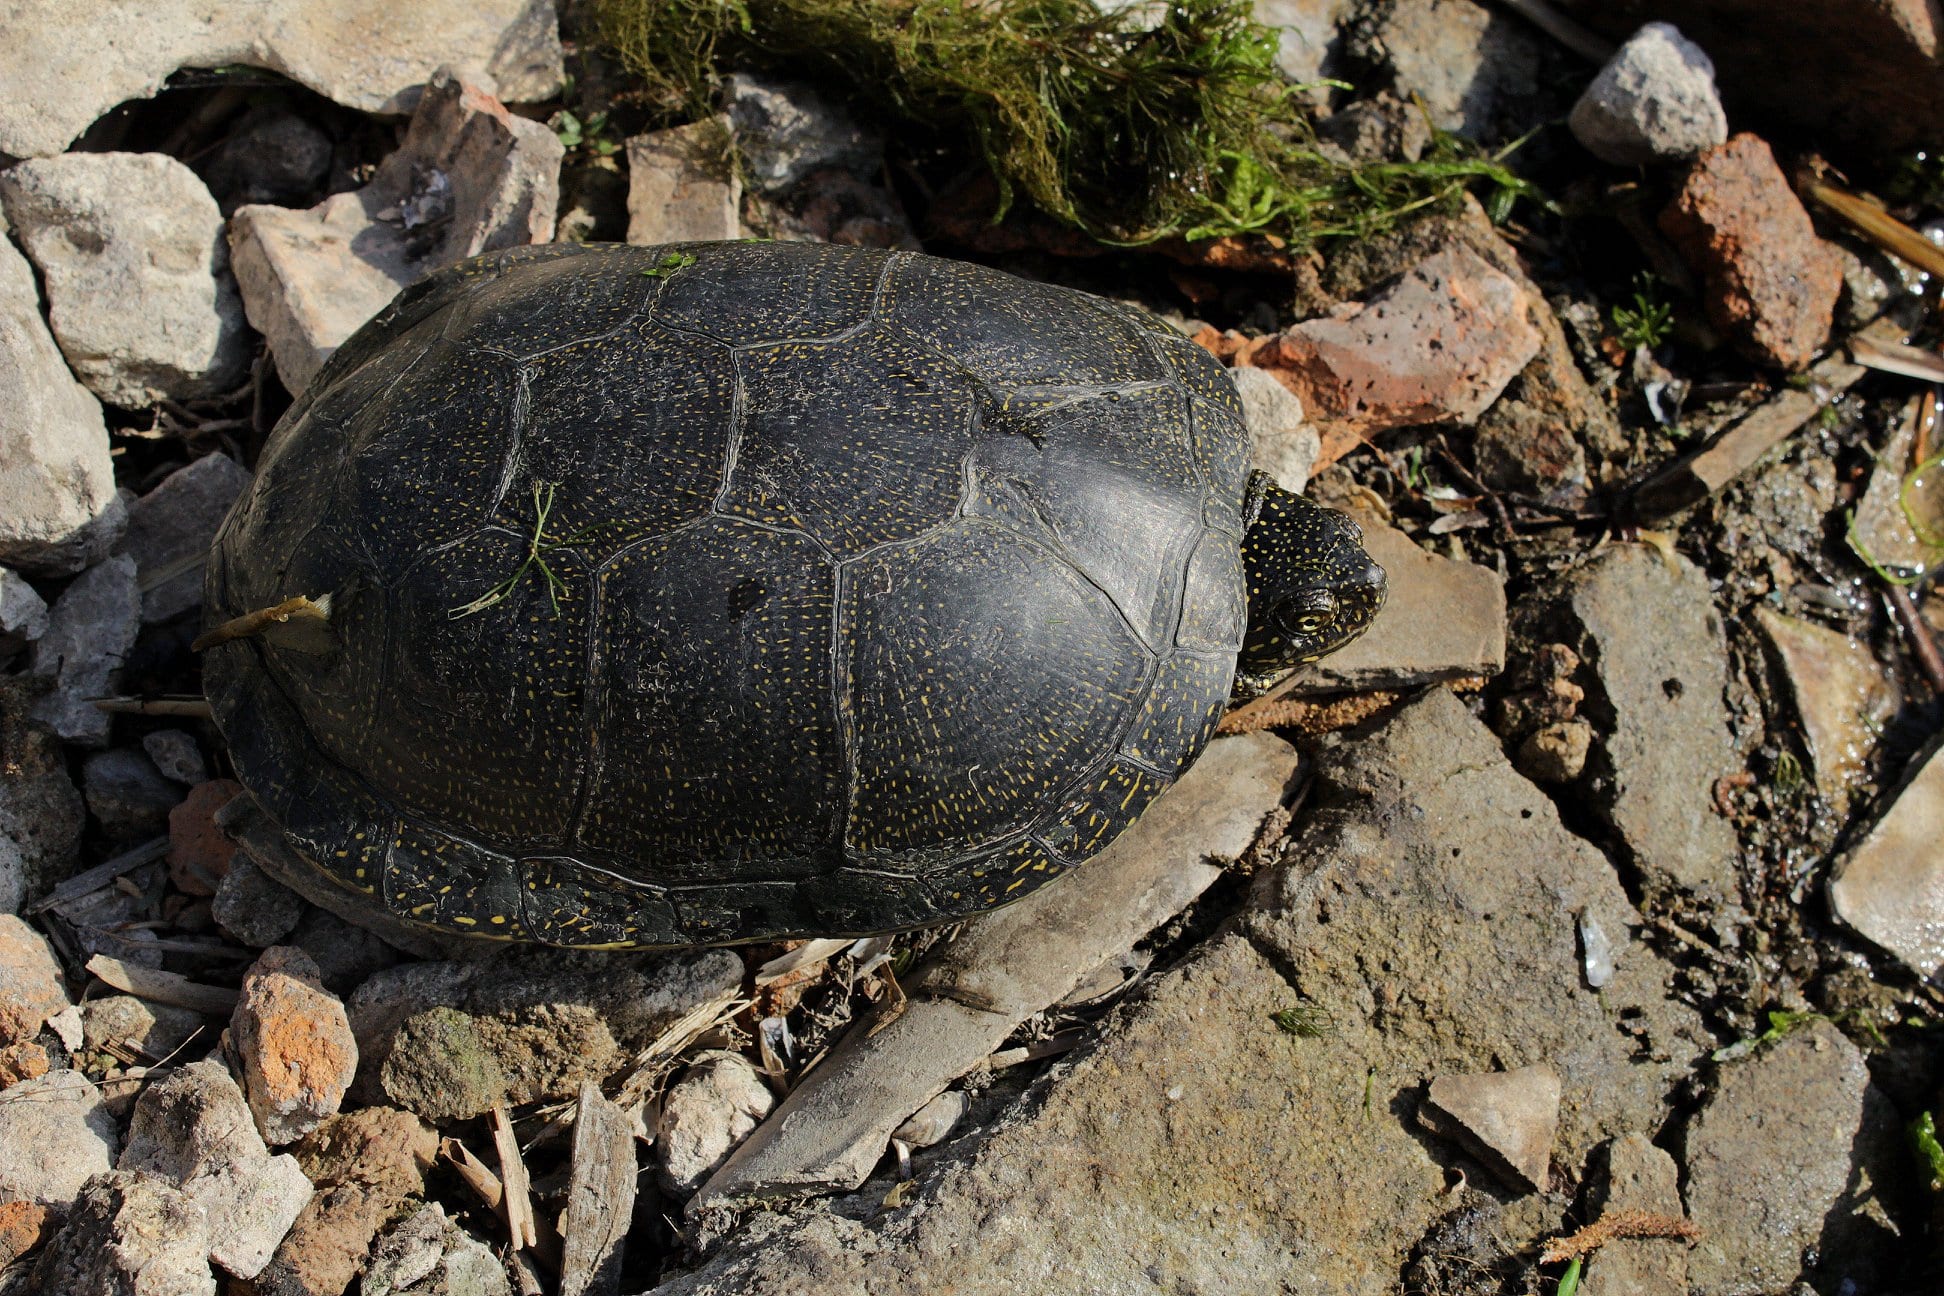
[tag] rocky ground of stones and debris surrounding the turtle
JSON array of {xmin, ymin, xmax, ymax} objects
[{"xmin": 0, "ymin": 0, "xmax": 1944, "ymax": 1296}]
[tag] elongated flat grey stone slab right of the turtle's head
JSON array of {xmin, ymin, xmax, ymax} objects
[{"xmin": 1540, "ymin": 544, "xmax": 1742, "ymax": 907}]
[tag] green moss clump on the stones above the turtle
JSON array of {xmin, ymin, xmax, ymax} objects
[{"xmin": 595, "ymin": 0, "xmax": 1528, "ymax": 247}]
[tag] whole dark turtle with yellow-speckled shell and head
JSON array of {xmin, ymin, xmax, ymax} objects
[{"xmin": 198, "ymin": 241, "xmax": 1384, "ymax": 948}]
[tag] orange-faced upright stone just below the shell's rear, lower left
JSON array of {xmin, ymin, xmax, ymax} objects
[{"xmin": 229, "ymin": 944, "xmax": 358, "ymax": 1146}]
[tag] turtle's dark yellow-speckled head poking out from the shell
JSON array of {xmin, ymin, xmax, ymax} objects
[{"xmin": 1236, "ymin": 472, "xmax": 1384, "ymax": 696}]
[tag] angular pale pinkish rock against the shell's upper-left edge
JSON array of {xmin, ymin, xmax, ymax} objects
[{"xmin": 229, "ymin": 70, "xmax": 566, "ymax": 394}]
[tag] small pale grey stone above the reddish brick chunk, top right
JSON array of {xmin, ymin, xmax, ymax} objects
[{"xmin": 1567, "ymin": 23, "xmax": 1728, "ymax": 167}]
